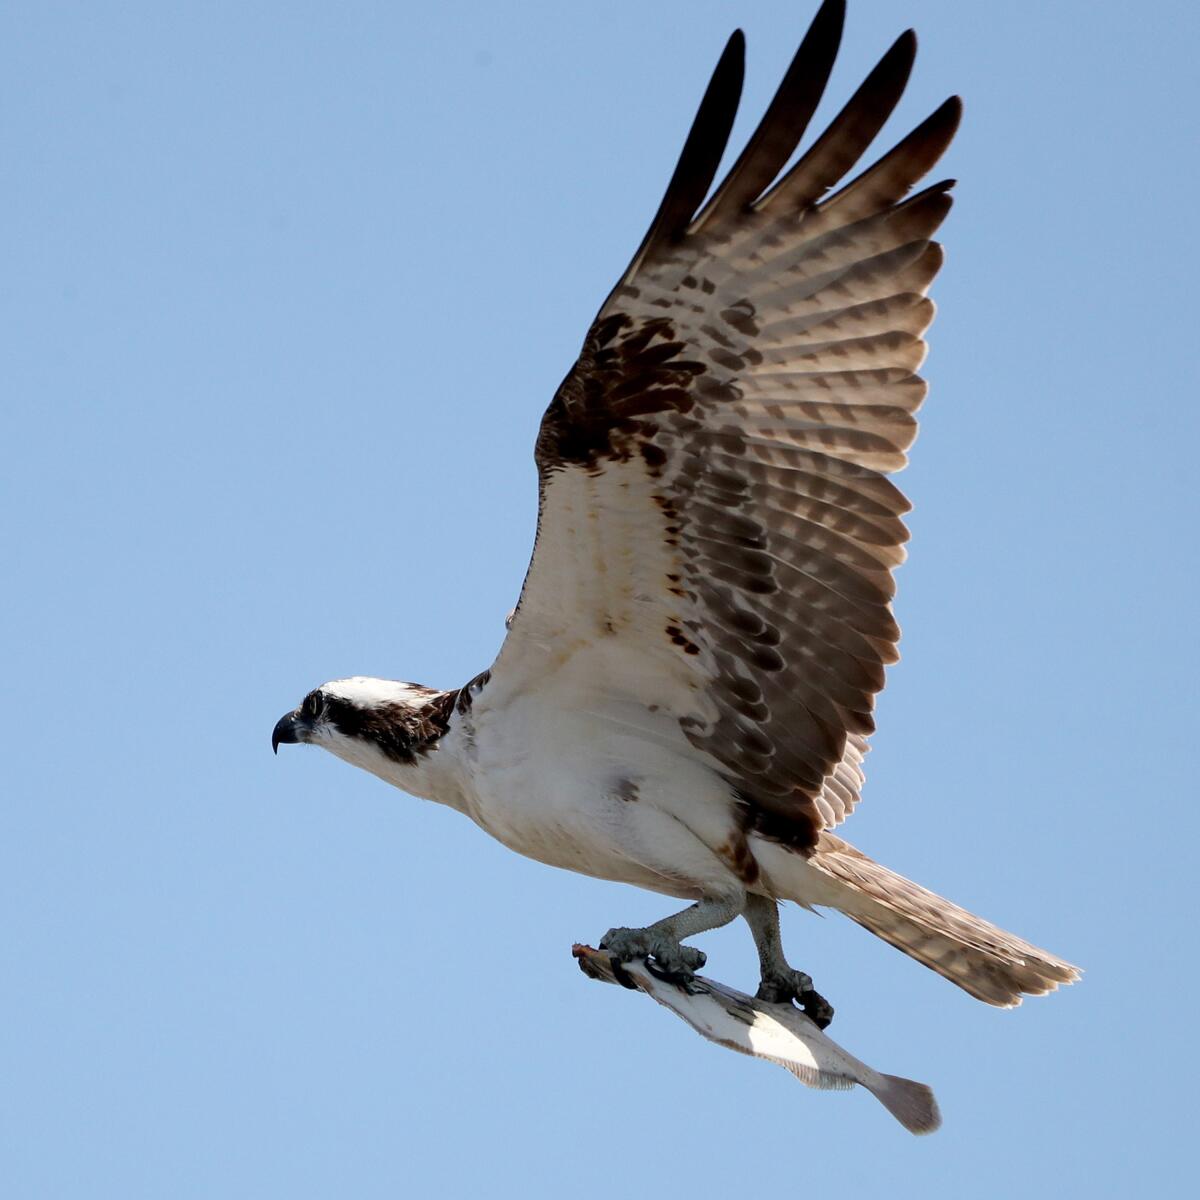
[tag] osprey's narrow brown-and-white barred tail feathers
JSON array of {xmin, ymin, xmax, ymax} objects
[{"xmin": 808, "ymin": 833, "xmax": 1081, "ymax": 1008}]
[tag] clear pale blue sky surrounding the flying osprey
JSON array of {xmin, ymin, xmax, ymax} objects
[{"xmin": 0, "ymin": 0, "xmax": 1200, "ymax": 1200}]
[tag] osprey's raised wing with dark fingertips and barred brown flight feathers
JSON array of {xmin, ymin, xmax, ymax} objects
[{"xmin": 484, "ymin": 0, "xmax": 960, "ymax": 847}]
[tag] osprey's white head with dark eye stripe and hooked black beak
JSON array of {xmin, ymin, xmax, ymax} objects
[{"xmin": 271, "ymin": 676, "xmax": 455, "ymax": 778}]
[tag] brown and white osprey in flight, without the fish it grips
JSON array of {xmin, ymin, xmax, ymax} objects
[{"xmin": 272, "ymin": 0, "xmax": 1079, "ymax": 1026}]
